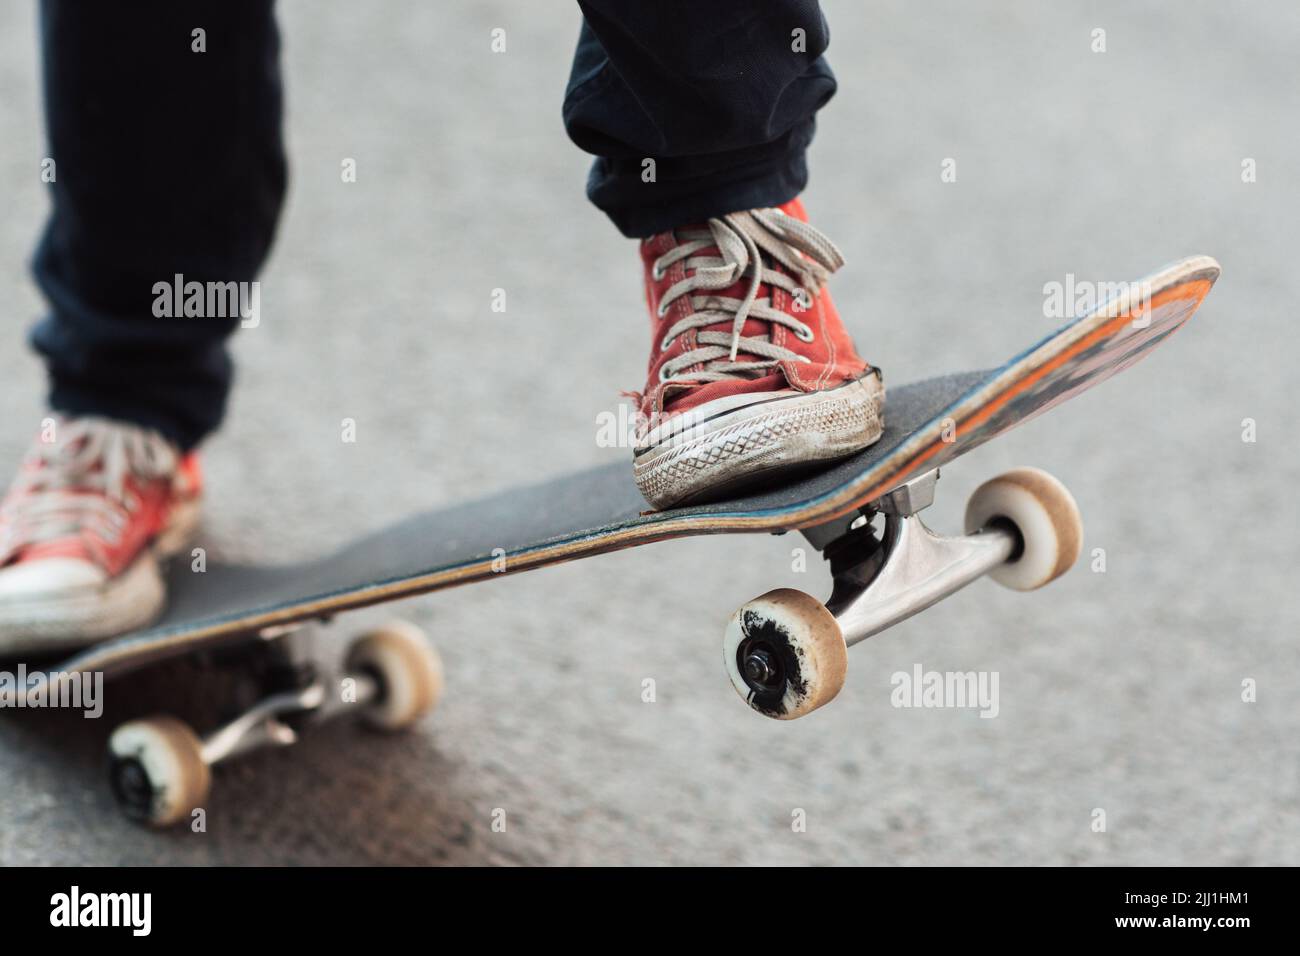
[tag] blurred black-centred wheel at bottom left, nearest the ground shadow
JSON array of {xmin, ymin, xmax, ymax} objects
[{"xmin": 108, "ymin": 717, "xmax": 212, "ymax": 827}]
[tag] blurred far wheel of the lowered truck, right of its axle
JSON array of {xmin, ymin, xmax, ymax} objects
[{"xmin": 347, "ymin": 620, "xmax": 443, "ymax": 730}]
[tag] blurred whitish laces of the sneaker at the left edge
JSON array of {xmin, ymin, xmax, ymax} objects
[{"xmin": 0, "ymin": 418, "xmax": 177, "ymax": 566}]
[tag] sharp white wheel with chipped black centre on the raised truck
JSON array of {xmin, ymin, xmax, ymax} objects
[{"xmin": 723, "ymin": 588, "xmax": 849, "ymax": 721}]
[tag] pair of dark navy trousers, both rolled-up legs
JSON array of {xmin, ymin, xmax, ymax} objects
[{"xmin": 31, "ymin": 0, "xmax": 835, "ymax": 447}]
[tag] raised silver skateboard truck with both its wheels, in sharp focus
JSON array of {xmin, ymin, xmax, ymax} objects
[{"xmin": 723, "ymin": 468, "xmax": 1083, "ymax": 719}]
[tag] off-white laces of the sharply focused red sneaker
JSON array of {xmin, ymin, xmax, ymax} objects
[{"xmin": 653, "ymin": 209, "xmax": 844, "ymax": 381}]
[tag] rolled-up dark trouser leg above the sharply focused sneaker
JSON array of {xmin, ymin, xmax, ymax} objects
[{"xmin": 564, "ymin": 0, "xmax": 836, "ymax": 237}]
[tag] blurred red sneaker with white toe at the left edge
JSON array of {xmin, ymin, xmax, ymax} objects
[{"xmin": 0, "ymin": 418, "xmax": 200, "ymax": 654}]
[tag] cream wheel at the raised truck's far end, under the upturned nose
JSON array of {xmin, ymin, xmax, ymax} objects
[{"xmin": 966, "ymin": 468, "xmax": 1083, "ymax": 591}]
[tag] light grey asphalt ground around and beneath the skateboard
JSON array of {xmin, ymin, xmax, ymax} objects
[{"xmin": 0, "ymin": 0, "xmax": 1300, "ymax": 864}]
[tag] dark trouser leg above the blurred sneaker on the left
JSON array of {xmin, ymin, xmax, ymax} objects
[{"xmin": 33, "ymin": 0, "xmax": 285, "ymax": 449}]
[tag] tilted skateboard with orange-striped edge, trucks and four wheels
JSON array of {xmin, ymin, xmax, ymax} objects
[{"xmin": 7, "ymin": 256, "xmax": 1219, "ymax": 825}]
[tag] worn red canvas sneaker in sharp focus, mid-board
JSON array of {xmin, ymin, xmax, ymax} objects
[{"xmin": 633, "ymin": 199, "xmax": 885, "ymax": 509}]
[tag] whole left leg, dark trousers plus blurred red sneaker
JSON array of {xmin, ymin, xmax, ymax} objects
[{"xmin": 0, "ymin": 0, "xmax": 285, "ymax": 654}]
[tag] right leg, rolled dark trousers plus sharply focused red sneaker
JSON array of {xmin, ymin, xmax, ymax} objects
[{"xmin": 564, "ymin": 0, "xmax": 884, "ymax": 509}]
